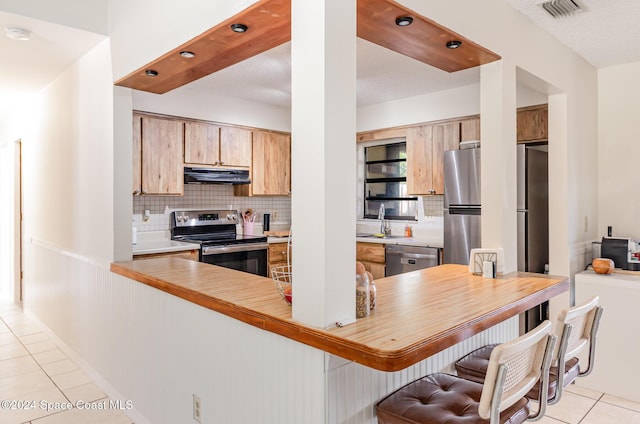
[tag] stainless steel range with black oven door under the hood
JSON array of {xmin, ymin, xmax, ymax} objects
[{"xmin": 171, "ymin": 210, "xmax": 268, "ymax": 277}]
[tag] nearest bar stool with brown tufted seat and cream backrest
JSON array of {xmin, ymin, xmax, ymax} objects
[{"xmin": 376, "ymin": 321, "xmax": 556, "ymax": 424}]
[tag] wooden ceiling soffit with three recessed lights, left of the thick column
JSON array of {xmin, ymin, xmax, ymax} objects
[{"xmin": 116, "ymin": 0, "xmax": 291, "ymax": 94}]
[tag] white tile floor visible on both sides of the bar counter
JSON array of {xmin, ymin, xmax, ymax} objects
[{"xmin": 0, "ymin": 303, "xmax": 640, "ymax": 424}]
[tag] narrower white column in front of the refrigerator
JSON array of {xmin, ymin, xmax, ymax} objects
[{"xmin": 480, "ymin": 59, "xmax": 518, "ymax": 272}]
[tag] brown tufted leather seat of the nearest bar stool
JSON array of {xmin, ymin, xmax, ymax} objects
[{"xmin": 376, "ymin": 374, "xmax": 529, "ymax": 424}]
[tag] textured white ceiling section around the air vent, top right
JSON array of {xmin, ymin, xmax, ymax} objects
[{"xmin": 506, "ymin": 0, "xmax": 640, "ymax": 68}]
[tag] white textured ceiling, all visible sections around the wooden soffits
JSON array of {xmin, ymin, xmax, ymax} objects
[{"xmin": 0, "ymin": 0, "xmax": 640, "ymax": 113}]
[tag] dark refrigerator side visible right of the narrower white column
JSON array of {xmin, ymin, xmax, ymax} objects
[{"xmin": 517, "ymin": 144, "xmax": 549, "ymax": 333}]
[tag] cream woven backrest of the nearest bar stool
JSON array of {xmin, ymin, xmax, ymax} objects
[{"xmin": 478, "ymin": 321, "xmax": 556, "ymax": 423}]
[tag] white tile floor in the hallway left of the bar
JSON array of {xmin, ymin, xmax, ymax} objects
[{"xmin": 0, "ymin": 303, "xmax": 132, "ymax": 424}]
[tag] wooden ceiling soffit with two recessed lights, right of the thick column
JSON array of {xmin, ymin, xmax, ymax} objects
[{"xmin": 358, "ymin": 0, "xmax": 500, "ymax": 72}]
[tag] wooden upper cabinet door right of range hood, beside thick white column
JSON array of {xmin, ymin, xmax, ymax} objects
[{"xmin": 251, "ymin": 131, "xmax": 291, "ymax": 196}]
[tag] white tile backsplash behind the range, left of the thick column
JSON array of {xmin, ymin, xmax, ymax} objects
[{"xmin": 133, "ymin": 184, "xmax": 291, "ymax": 231}]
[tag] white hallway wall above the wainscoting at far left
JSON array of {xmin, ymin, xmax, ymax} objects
[{"xmin": 21, "ymin": 41, "xmax": 113, "ymax": 261}]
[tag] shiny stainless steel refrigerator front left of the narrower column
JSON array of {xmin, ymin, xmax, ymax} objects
[{"xmin": 444, "ymin": 148, "xmax": 481, "ymax": 265}]
